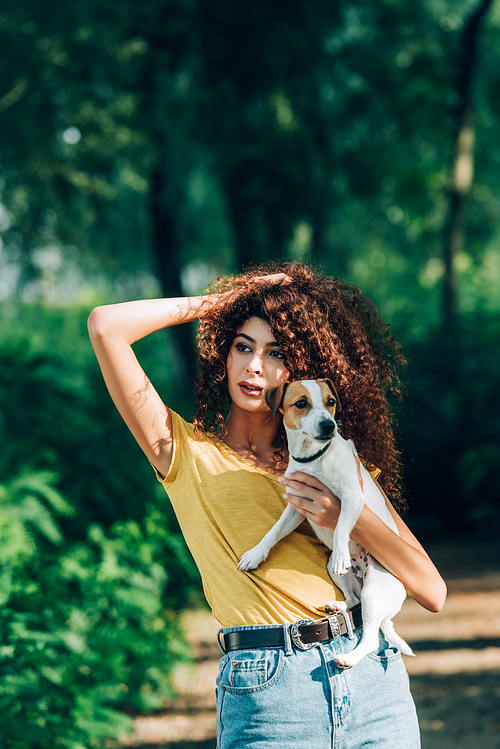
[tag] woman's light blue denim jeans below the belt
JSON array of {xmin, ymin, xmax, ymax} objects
[{"xmin": 216, "ymin": 626, "xmax": 420, "ymax": 749}]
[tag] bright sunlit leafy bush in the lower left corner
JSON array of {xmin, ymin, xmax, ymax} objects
[{"xmin": 0, "ymin": 473, "xmax": 191, "ymax": 749}]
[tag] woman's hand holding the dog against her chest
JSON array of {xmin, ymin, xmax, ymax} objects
[{"xmin": 278, "ymin": 472, "xmax": 340, "ymax": 530}]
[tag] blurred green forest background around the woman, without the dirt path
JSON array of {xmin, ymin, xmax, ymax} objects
[{"xmin": 0, "ymin": 0, "xmax": 500, "ymax": 749}]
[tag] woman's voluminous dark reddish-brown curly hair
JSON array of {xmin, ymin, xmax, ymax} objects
[{"xmin": 193, "ymin": 262, "xmax": 406, "ymax": 508}]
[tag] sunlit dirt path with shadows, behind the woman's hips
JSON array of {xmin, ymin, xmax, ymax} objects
[{"xmin": 122, "ymin": 544, "xmax": 500, "ymax": 749}]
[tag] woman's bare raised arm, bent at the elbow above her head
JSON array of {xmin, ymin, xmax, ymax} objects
[{"xmin": 88, "ymin": 294, "xmax": 215, "ymax": 476}]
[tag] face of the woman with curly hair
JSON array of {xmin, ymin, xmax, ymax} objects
[{"xmin": 227, "ymin": 317, "xmax": 290, "ymax": 412}]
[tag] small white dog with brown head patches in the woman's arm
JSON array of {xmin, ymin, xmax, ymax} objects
[{"xmin": 238, "ymin": 380, "xmax": 413, "ymax": 668}]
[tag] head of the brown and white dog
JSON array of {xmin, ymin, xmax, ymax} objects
[{"xmin": 264, "ymin": 379, "xmax": 341, "ymax": 442}]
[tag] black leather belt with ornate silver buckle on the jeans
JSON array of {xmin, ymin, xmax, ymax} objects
[{"xmin": 219, "ymin": 605, "xmax": 363, "ymax": 653}]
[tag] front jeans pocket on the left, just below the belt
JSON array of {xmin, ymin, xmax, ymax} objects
[{"xmin": 220, "ymin": 649, "xmax": 284, "ymax": 694}]
